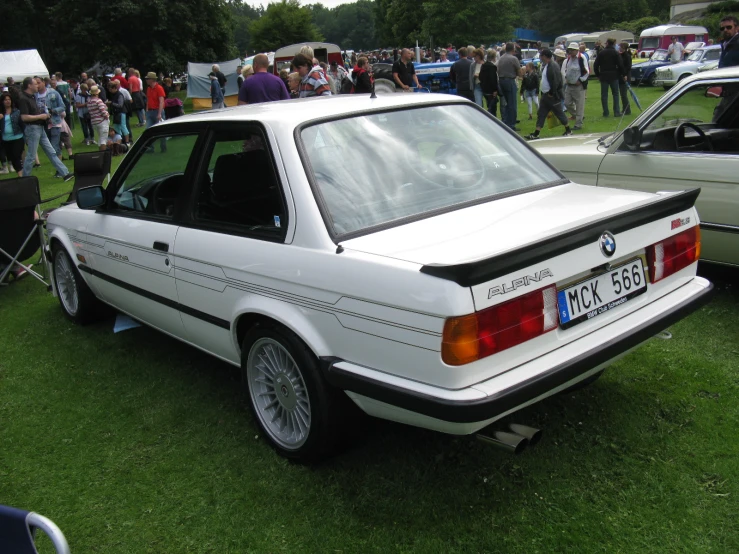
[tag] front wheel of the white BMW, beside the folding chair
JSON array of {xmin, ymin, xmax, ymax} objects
[{"xmin": 51, "ymin": 244, "xmax": 107, "ymax": 325}]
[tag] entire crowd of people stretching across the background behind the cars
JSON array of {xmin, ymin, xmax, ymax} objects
[{"xmin": 0, "ymin": 15, "xmax": 739, "ymax": 176}]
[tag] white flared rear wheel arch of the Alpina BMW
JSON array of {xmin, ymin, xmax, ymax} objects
[{"xmin": 231, "ymin": 297, "xmax": 330, "ymax": 357}]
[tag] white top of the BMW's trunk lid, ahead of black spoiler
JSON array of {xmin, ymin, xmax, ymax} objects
[{"xmin": 341, "ymin": 183, "xmax": 656, "ymax": 265}]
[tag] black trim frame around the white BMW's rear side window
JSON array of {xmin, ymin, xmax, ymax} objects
[{"xmin": 180, "ymin": 121, "xmax": 292, "ymax": 244}]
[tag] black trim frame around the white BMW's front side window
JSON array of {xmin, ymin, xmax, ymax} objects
[{"xmin": 97, "ymin": 122, "xmax": 205, "ymax": 225}]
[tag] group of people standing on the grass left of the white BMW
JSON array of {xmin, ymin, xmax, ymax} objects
[{"xmin": 0, "ymin": 67, "xmax": 186, "ymax": 180}]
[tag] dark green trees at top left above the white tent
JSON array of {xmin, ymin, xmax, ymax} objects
[{"xmin": 3, "ymin": 0, "xmax": 236, "ymax": 75}]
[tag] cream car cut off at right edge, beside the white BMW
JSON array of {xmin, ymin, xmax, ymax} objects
[{"xmin": 531, "ymin": 67, "xmax": 739, "ymax": 266}]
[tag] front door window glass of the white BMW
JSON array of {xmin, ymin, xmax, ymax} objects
[{"xmin": 113, "ymin": 134, "xmax": 198, "ymax": 217}]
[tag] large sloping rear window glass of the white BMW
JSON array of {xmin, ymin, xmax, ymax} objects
[{"xmin": 301, "ymin": 104, "xmax": 561, "ymax": 235}]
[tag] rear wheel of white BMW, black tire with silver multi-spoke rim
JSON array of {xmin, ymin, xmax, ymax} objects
[{"xmin": 241, "ymin": 322, "xmax": 351, "ymax": 463}]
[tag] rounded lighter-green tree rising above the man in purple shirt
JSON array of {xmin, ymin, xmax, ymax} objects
[{"xmin": 249, "ymin": 0, "xmax": 323, "ymax": 52}]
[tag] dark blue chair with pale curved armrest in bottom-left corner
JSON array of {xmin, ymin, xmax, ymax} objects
[{"xmin": 0, "ymin": 505, "xmax": 70, "ymax": 554}]
